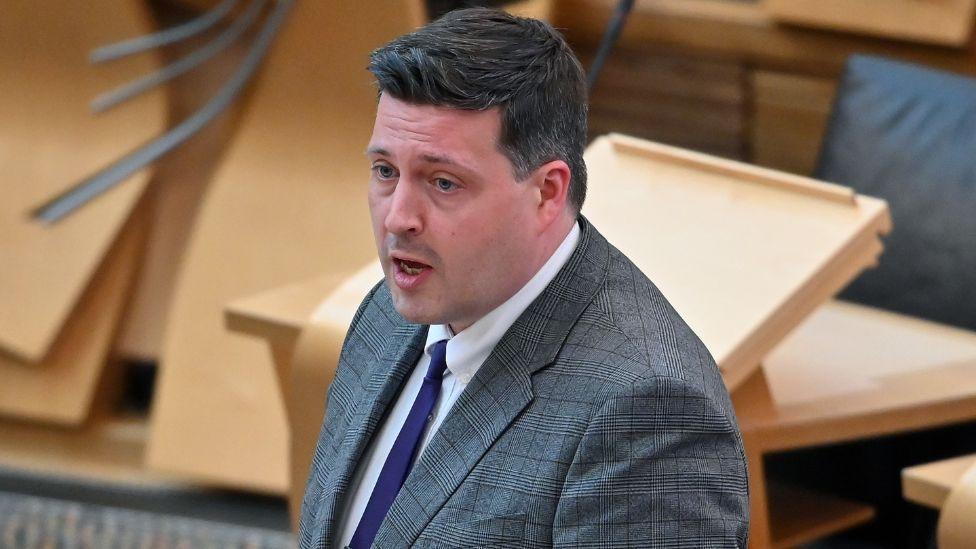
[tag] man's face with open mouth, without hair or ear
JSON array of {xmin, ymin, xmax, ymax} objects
[{"xmin": 367, "ymin": 94, "xmax": 539, "ymax": 332}]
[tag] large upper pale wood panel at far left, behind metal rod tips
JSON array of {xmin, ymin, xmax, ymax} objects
[{"xmin": 0, "ymin": 0, "xmax": 166, "ymax": 363}]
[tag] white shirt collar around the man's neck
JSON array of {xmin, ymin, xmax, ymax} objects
[{"xmin": 425, "ymin": 223, "xmax": 580, "ymax": 383}]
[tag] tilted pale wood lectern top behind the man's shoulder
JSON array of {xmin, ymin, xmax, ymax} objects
[{"xmin": 583, "ymin": 135, "xmax": 889, "ymax": 389}]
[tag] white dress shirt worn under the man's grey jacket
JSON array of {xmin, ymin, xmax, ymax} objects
[{"xmin": 335, "ymin": 223, "xmax": 580, "ymax": 547}]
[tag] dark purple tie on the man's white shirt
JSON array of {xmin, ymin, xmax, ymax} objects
[{"xmin": 349, "ymin": 339, "xmax": 447, "ymax": 549}]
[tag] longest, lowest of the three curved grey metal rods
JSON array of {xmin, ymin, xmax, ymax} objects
[{"xmin": 32, "ymin": 0, "xmax": 294, "ymax": 223}]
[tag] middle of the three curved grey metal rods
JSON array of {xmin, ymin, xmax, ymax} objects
[{"xmin": 91, "ymin": 0, "xmax": 265, "ymax": 112}]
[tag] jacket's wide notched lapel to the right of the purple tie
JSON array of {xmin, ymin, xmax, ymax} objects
[{"xmin": 374, "ymin": 218, "xmax": 609, "ymax": 547}]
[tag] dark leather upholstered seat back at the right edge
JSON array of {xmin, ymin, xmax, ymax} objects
[{"xmin": 816, "ymin": 56, "xmax": 976, "ymax": 329}]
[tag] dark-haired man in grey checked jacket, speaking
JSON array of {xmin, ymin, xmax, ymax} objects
[{"xmin": 300, "ymin": 9, "xmax": 748, "ymax": 548}]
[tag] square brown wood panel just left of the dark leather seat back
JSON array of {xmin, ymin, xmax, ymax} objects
[{"xmin": 750, "ymin": 71, "xmax": 836, "ymax": 175}]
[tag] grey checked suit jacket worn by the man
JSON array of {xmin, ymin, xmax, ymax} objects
[{"xmin": 299, "ymin": 218, "xmax": 748, "ymax": 548}]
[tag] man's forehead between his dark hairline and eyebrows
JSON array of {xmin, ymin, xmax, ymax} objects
[{"xmin": 369, "ymin": 94, "xmax": 501, "ymax": 154}]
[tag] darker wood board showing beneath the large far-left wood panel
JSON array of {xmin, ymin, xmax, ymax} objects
[{"xmin": 0, "ymin": 203, "xmax": 147, "ymax": 424}]
